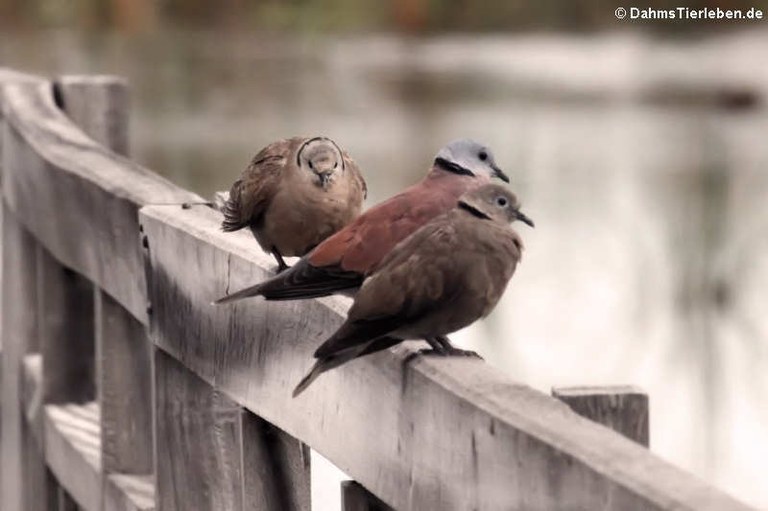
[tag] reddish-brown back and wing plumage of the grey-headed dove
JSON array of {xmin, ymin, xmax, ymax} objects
[{"xmin": 307, "ymin": 168, "xmax": 489, "ymax": 275}]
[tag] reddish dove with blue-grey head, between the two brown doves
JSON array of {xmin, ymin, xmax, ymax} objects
[{"xmin": 216, "ymin": 139, "xmax": 509, "ymax": 303}]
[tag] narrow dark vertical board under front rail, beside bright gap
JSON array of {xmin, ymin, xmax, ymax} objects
[{"xmin": 242, "ymin": 411, "xmax": 312, "ymax": 511}]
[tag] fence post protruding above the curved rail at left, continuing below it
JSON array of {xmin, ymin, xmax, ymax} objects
[{"xmin": 55, "ymin": 76, "xmax": 152, "ymax": 475}]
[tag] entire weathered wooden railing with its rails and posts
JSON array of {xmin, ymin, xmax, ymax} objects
[{"xmin": 0, "ymin": 72, "xmax": 747, "ymax": 511}]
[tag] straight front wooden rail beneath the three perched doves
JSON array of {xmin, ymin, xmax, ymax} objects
[{"xmin": 141, "ymin": 202, "xmax": 748, "ymax": 510}]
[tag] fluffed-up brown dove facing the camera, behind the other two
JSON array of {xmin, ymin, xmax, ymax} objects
[{"xmin": 221, "ymin": 137, "xmax": 366, "ymax": 271}]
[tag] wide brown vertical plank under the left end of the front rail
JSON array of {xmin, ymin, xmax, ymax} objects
[{"xmin": 155, "ymin": 350, "xmax": 248, "ymax": 511}]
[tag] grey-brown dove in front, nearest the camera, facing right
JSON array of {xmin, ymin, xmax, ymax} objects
[{"xmin": 293, "ymin": 184, "xmax": 533, "ymax": 397}]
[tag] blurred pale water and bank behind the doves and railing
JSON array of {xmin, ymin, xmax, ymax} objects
[{"xmin": 0, "ymin": 0, "xmax": 768, "ymax": 510}]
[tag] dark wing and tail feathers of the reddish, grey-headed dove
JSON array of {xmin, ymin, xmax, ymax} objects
[{"xmin": 213, "ymin": 259, "xmax": 363, "ymax": 304}]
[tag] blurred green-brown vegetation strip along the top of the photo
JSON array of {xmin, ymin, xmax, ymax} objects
[{"xmin": 0, "ymin": 0, "xmax": 768, "ymax": 33}]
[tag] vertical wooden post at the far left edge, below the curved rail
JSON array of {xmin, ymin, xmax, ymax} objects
[{"xmin": 1, "ymin": 204, "xmax": 46, "ymax": 511}]
